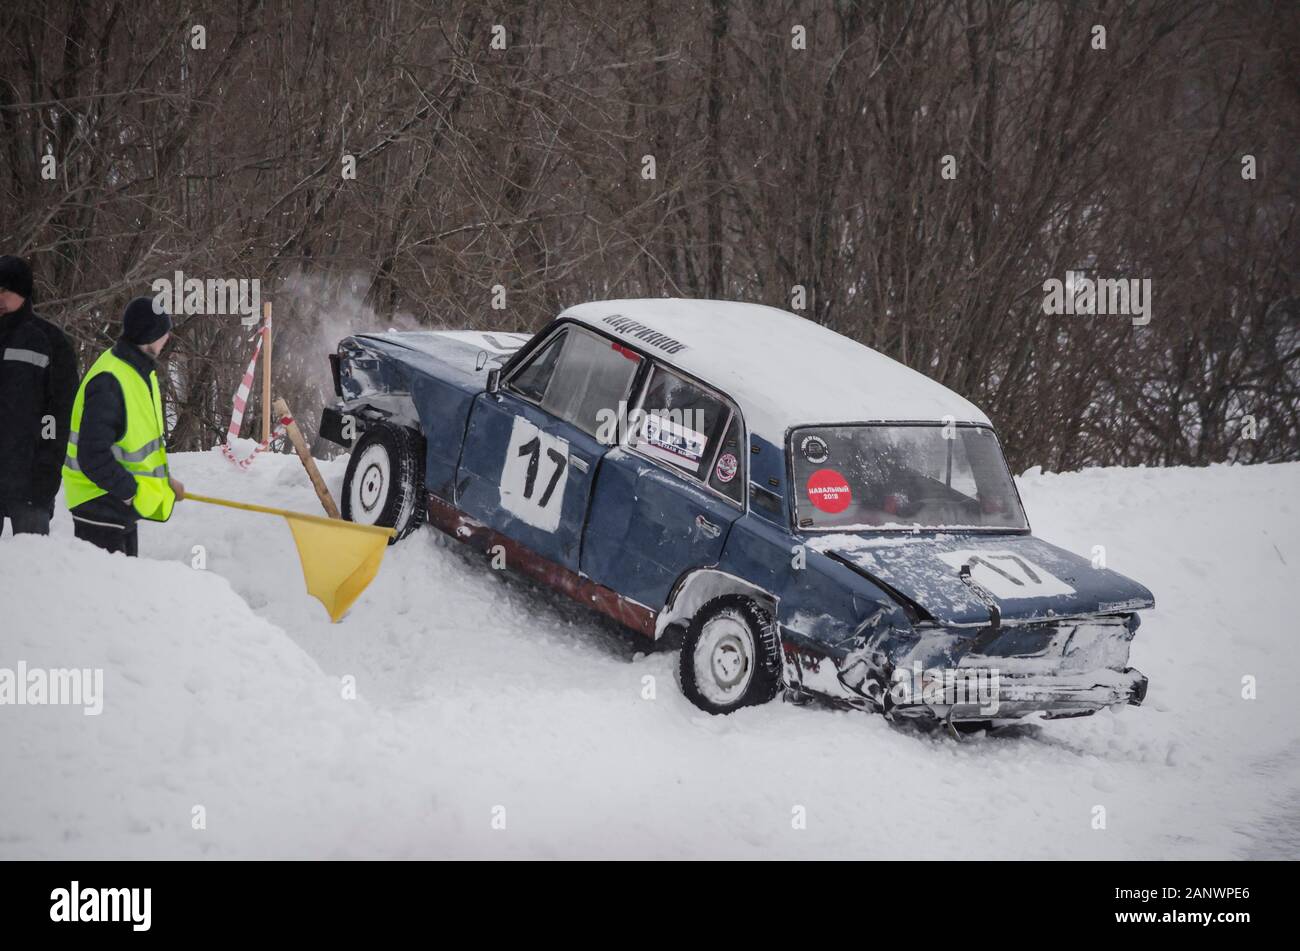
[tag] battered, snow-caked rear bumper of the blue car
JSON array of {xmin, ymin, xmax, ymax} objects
[{"xmin": 885, "ymin": 668, "xmax": 1147, "ymax": 722}]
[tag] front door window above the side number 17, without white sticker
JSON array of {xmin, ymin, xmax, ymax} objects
[{"xmin": 510, "ymin": 327, "xmax": 641, "ymax": 435}]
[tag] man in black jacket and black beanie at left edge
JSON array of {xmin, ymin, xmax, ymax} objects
[{"xmin": 0, "ymin": 255, "xmax": 78, "ymax": 535}]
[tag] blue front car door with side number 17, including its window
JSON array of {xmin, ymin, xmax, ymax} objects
[{"xmin": 455, "ymin": 323, "xmax": 641, "ymax": 572}]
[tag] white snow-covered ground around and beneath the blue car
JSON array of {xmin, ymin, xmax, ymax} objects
[{"xmin": 0, "ymin": 453, "xmax": 1300, "ymax": 859}]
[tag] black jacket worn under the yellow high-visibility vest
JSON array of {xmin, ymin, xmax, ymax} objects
[{"xmin": 73, "ymin": 340, "xmax": 155, "ymax": 525}]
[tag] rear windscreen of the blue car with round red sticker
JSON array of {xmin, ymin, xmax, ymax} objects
[{"xmin": 790, "ymin": 424, "xmax": 1028, "ymax": 530}]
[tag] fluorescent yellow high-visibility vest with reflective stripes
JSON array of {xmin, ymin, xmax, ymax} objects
[{"xmin": 64, "ymin": 349, "xmax": 176, "ymax": 522}]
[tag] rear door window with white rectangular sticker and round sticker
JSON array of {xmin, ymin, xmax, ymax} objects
[{"xmin": 631, "ymin": 366, "xmax": 745, "ymax": 501}]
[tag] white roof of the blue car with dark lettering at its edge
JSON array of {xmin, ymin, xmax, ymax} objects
[{"xmin": 560, "ymin": 298, "xmax": 988, "ymax": 446}]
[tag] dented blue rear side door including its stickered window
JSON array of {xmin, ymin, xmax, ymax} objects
[{"xmin": 581, "ymin": 365, "xmax": 746, "ymax": 611}]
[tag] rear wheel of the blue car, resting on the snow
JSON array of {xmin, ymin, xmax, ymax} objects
[{"xmin": 677, "ymin": 595, "xmax": 781, "ymax": 715}]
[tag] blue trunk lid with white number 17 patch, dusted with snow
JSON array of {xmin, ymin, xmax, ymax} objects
[{"xmin": 809, "ymin": 534, "xmax": 1154, "ymax": 625}]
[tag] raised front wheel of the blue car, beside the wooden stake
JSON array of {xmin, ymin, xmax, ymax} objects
[{"xmin": 342, "ymin": 422, "xmax": 428, "ymax": 544}]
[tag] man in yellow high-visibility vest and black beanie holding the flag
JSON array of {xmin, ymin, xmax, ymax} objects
[{"xmin": 64, "ymin": 298, "xmax": 185, "ymax": 556}]
